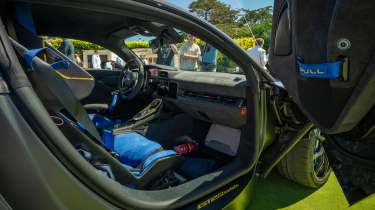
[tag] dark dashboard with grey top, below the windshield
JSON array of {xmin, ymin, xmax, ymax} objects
[{"xmin": 147, "ymin": 65, "xmax": 247, "ymax": 128}]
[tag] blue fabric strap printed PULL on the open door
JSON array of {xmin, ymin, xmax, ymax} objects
[{"xmin": 298, "ymin": 61, "xmax": 342, "ymax": 79}]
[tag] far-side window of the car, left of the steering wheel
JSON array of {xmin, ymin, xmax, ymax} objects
[{"xmin": 46, "ymin": 38, "xmax": 125, "ymax": 70}]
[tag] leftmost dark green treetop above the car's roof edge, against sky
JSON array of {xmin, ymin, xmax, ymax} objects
[{"xmin": 189, "ymin": 0, "xmax": 239, "ymax": 25}]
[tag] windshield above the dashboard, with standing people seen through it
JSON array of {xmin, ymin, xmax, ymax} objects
[{"xmin": 125, "ymin": 29, "xmax": 242, "ymax": 74}]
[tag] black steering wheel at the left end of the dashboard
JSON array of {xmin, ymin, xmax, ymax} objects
[{"xmin": 118, "ymin": 60, "xmax": 145, "ymax": 100}]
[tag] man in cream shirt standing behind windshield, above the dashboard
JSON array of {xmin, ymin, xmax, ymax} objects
[{"xmin": 179, "ymin": 34, "xmax": 201, "ymax": 71}]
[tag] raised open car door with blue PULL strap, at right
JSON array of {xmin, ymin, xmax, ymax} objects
[{"xmin": 269, "ymin": 0, "xmax": 375, "ymax": 203}]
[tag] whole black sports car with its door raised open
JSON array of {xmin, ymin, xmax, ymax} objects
[{"xmin": 0, "ymin": 0, "xmax": 375, "ymax": 209}]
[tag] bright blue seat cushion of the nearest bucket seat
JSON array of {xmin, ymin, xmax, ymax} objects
[{"xmin": 103, "ymin": 130, "xmax": 162, "ymax": 168}]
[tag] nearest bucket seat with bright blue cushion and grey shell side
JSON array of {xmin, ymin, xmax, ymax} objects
[{"xmin": 10, "ymin": 38, "xmax": 183, "ymax": 186}]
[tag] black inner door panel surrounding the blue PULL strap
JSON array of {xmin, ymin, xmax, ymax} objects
[{"xmin": 269, "ymin": 0, "xmax": 375, "ymax": 133}]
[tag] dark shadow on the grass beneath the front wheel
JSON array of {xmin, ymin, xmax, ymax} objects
[{"xmin": 247, "ymin": 172, "xmax": 316, "ymax": 210}]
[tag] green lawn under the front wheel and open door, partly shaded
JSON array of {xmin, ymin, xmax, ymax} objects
[{"xmin": 247, "ymin": 172, "xmax": 375, "ymax": 210}]
